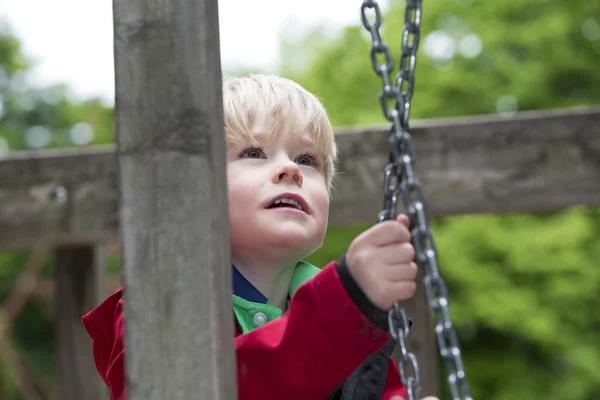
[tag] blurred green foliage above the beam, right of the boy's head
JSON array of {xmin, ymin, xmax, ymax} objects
[{"xmin": 280, "ymin": 0, "xmax": 600, "ymax": 126}]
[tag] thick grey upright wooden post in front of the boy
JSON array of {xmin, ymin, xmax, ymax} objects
[{"xmin": 113, "ymin": 0, "xmax": 237, "ymax": 400}]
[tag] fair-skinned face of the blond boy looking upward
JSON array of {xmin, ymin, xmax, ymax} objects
[{"xmin": 227, "ymin": 114, "xmax": 329, "ymax": 262}]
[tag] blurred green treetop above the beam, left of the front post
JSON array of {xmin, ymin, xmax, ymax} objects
[{"xmin": 0, "ymin": 23, "xmax": 114, "ymax": 156}]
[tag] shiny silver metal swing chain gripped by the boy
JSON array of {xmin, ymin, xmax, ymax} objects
[{"xmin": 361, "ymin": 0, "xmax": 472, "ymax": 400}]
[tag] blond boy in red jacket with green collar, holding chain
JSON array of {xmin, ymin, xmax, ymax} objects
[{"xmin": 83, "ymin": 75, "xmax": 438, "ymax": 400}]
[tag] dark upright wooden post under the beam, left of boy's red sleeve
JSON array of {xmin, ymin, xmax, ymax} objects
[{"xmin": 54, "ymin": 246, "xmax": 106, "ymax": 400}]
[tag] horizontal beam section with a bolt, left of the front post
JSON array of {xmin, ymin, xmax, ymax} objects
[{"xmin": 0, "ymin": 146, "xmax": 119, "ymax": 250}]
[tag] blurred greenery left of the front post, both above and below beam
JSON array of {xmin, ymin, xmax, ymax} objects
[{"xmin": 0, "ymin": 21, "xmax": 114, "ymax": 399}]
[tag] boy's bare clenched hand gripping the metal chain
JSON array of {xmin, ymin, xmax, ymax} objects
[{"xmin": 346, "ymin": 214, "xmax": 417, "ymax": 311}]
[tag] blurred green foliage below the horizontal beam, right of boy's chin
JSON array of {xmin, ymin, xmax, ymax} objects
[{"xmin": 308, "ymin": 209, "xmax": 600, "ymax": 400}]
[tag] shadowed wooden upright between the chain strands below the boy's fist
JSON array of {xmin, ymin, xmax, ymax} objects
[{"xmin": 393, "ymin": 271, "xmax": 440, "ymax": 397}]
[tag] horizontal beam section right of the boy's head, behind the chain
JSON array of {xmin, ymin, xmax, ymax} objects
[{"xmin": 331, "ymin": 108, "xmax": 600, "ymax": 225}]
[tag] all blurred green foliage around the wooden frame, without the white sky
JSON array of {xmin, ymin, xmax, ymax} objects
[{"xmin": 0, "ymin": 0, "xmax": 600, "ymax": 400}]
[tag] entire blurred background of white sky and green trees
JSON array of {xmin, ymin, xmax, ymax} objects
[{"xmin": 0, "ymin": 0, "xmax": 600, "ymax": 400}]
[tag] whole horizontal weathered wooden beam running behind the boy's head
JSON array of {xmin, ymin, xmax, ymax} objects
[{"xmin": 0, "ymin": 108, "xmax": 600, "ymax": 250}]
